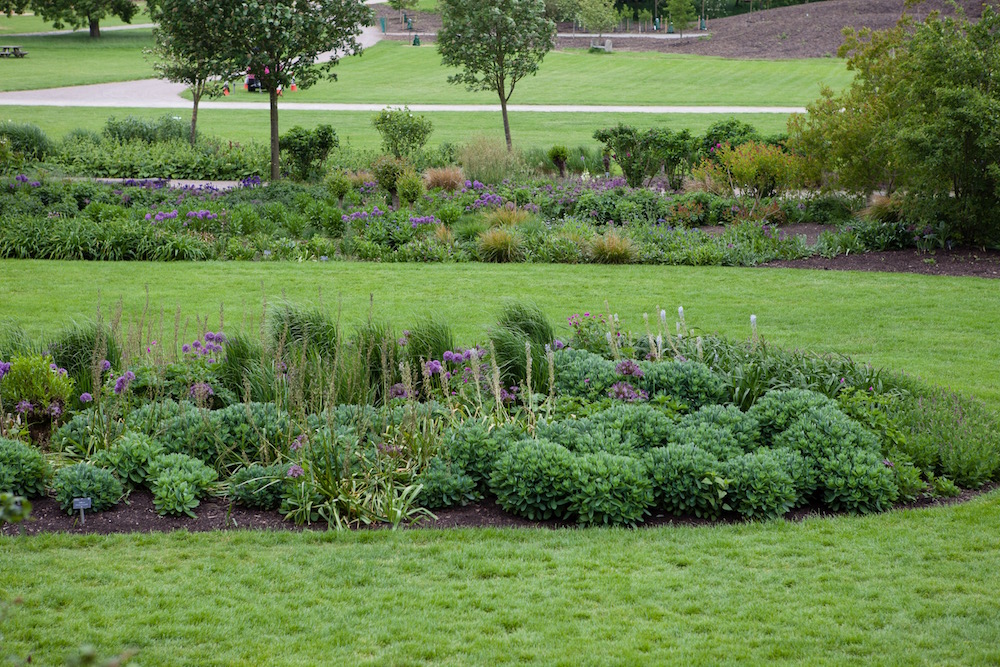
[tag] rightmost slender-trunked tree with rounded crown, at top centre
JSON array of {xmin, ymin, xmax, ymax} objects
[{"xmin": 437, "ymin": 0, "xmax": 556, "ymax": 150}]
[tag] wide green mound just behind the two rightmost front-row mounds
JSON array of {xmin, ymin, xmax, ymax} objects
[{"xmin": 774, "ymin": 406, "xmax": 881, "ymax": 461}]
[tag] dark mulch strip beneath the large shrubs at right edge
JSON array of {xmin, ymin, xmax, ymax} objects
[{"xmin": 764, "ymin": 249, "xmax": 1000, "ymax": 278}]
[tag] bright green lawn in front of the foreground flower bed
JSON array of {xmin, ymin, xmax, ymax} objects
[{"xmin": 0, "ymin": 492, "xmax": 1000, "ymax": 665}]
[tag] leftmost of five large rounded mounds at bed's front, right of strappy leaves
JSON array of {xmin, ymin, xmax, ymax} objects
[{"xmin": 490, "ymin": 439, "xmax": 577, "ymax": 520}]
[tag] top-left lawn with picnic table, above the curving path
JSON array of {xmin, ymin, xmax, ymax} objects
[{"xmin": 0, "ymin": 28, "xmax": 154, "ymax": 92}]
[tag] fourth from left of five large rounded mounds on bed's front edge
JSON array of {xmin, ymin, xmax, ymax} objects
[{"xmin": 724, "ymin": 449, "xmax": 798, "ymax": 519}]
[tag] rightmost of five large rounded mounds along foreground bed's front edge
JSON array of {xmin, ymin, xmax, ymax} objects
[{"xmin": 819, "ymin": 448, "xmax": 899, "ymax": 514}]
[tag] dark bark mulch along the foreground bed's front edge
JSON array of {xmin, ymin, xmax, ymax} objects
[{"xmin": 0, "ymin": 483, "xmax": 1000, "ymax": 535}]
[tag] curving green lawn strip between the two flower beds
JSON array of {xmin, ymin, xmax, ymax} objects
[{"xmin": 0, "ymin": 260, "xmax": 1000, "ymax": 404}]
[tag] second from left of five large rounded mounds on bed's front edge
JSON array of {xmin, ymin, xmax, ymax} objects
[{"xmin": 567, "ymin": 452, "xmax": 654, "ymax": 526}]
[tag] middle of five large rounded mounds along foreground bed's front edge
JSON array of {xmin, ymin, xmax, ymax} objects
[{"xmin": 645, "ymin": 445, "xmax": 731, "ymax": 519}]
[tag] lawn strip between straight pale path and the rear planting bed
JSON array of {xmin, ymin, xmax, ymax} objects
[{"xmin": 0, "ymin": 103, "xmax": 788, "ymax": 150}]
